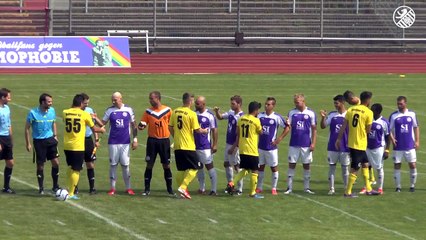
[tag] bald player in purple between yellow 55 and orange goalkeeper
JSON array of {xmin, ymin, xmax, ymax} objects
[{"xmin": 102, "ymin": 92, "xmax": 138, "ymax": 196}]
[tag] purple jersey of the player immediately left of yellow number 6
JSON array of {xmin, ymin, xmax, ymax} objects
[{"xmin": 325, "ymin": 111, "xmax": 349, "ymax": 152}]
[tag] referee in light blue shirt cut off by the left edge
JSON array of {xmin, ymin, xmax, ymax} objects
[{"xmin": 0, "ymin": 88, "xmax": 15, "ymax": 194}]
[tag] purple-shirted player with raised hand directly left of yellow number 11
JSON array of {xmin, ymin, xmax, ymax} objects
[{"xmin": 213, "ymin": 95, "xmax": 244, "ymax": 195}]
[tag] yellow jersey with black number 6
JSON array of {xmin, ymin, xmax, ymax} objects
[{"xmin": 345, "ymin": 105, "xmax": 373, "ymax": 151}]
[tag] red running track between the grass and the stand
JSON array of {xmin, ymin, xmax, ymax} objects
[{"xmin": 0, "ymin": 53, "xmax": 426, "ymax": 74}]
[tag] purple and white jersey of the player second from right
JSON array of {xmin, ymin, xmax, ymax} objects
[{"xmin": 367, "ymin": 117, "xmax": 389, "ymax": 149}]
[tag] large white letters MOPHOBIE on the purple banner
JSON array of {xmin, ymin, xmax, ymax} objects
[{"xmin": 0, "ymin": 51, "xmax": 80, "ymax": 64}]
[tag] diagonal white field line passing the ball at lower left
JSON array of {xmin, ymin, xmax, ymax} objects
[{"xmin": 0, "ymin": 172, "xmax": 148, "ymax": 240}]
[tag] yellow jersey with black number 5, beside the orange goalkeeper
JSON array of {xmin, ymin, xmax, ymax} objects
[{"xmin": 169, "ymin": 107, "xmax": 200, "ymax": 151}]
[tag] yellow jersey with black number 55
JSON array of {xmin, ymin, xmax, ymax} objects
[{"xmin": 62, "ymin": 107, "xmax": 95, "ymax": 151}]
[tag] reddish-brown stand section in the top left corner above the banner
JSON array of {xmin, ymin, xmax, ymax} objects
[{"xmin": 0, "ymin": 0, "xmax": 49, "ymax": 36}]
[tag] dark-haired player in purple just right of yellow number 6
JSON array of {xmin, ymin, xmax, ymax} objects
[{"xmin": 360, "ymin": 103, "xmax": 389, "ymax": 194}]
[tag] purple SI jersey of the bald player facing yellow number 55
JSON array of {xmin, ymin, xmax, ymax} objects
[{"xmin": 102, "ymin": 105, "xmax": 135, "ymax": 144}]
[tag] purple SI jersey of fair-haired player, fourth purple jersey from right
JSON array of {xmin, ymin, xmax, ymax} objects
[{"xmin": 288, "ymin": 108, "xmax": 317, "ymax": 147}]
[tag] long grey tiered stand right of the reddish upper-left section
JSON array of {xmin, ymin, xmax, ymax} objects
[{"xmin": 15, "ymin": 0, "xmax": 426, "ymax": 52}]
